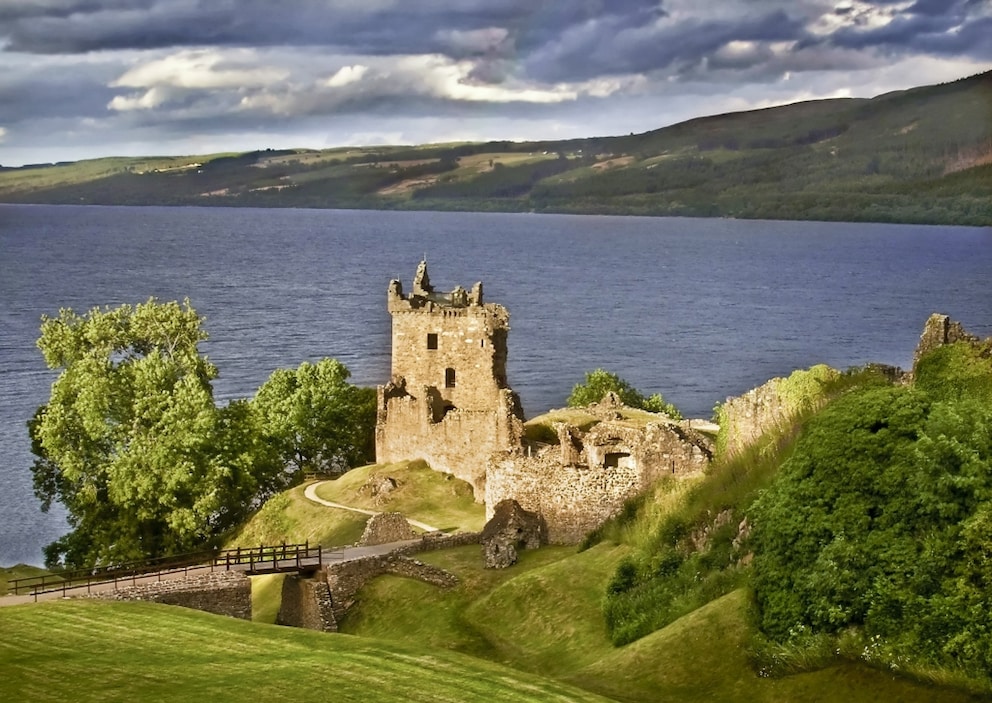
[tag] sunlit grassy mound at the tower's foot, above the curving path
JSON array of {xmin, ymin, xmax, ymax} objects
[{"xmin": 308, "ymin": 461, "xmax": 486, "ymax": 532}]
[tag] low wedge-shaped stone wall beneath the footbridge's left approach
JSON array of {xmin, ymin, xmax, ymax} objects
[{"xmin": 92, "ymin": 571, "xmax": 251, "ymax": 620}]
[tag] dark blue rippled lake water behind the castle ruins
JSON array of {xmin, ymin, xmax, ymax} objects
[{"xmin": 0, "ymin": 206, "xmax": 992, "ymax": 565}]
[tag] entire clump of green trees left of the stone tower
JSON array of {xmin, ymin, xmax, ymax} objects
[{"xmin": 28, "ymin": 299, "xmax": 374, "ymax": 567}]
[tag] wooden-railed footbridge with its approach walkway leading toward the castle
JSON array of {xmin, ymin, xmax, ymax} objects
[{"xmin": 7, "ymin": 542, "xmax": 326, "ymax": 601}]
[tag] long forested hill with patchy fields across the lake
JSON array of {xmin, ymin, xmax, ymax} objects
[{"xmin": 0, "ymin": 71, "xmax": 992, "ymax": 225}]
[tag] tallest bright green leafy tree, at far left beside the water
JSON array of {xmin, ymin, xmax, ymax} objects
[{"xmin": 29, "ymin": 298, "xmax": 231, "ymax": 566}]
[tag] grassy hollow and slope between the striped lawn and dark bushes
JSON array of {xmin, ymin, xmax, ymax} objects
[{"xmin": 343, "ymin": 544, "xmax": 979, "ymax": 703}]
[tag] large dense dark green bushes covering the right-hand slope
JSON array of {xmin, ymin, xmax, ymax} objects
[{"xmin": 751, "ymin": 345, "xmax": 992, "ymax": 678}]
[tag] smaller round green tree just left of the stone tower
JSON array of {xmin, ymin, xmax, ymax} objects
[{"xmin": 251, "ymin": 359, "xmax": 376, "ymax": 480}]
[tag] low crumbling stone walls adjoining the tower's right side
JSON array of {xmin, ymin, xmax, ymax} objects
[{"xmin": 486, "ymin": 421, "xmax": 712, "ymax": 544}]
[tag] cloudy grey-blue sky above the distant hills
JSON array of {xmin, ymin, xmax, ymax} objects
[{"xmin": 0, "ymin": 0, "xmax": 992, "ymax": 166}]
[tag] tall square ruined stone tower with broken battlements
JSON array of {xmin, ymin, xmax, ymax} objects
[{"xmin": 375, "ymin": 261, "xmax": 523, "ymax": 501}]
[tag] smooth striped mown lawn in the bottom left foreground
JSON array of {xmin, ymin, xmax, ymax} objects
[{"xmin": 0, "ymin": 601, "xmax": 606, "ymax": 703}]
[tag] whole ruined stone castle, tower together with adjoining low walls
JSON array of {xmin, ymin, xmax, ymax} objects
[{"xmin": 375, "ymin": 261, "xmax": 712, "ymax": 543}]
